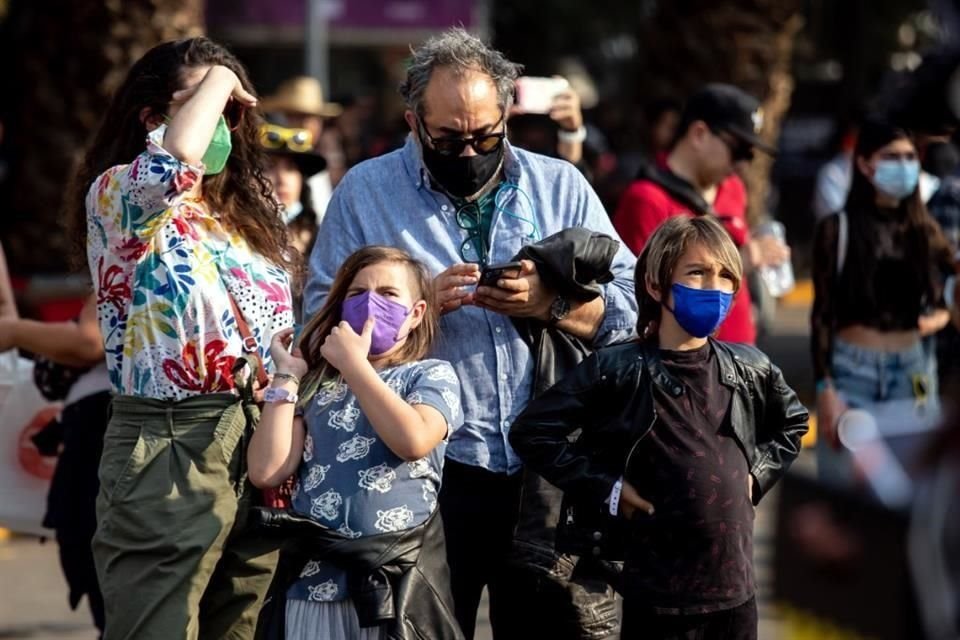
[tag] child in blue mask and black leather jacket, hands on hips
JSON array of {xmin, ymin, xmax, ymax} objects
[{"xmin": 510, "ymin": 216, "xmax": 808, "ymax": 640}]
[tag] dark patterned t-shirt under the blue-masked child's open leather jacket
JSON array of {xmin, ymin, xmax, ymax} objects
[{"xmin": 625, "ymin": 343, "xmax": 755, "ymax": 614}]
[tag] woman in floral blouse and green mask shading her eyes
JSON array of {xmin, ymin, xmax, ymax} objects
[{"xmin": 65, "ymin": 38, "xmax": 292, "ymax": 640}]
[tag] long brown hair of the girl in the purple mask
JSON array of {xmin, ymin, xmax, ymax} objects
[{"xmin": 300, "ymin": 245, "xmax": 438, "ymax": 395}]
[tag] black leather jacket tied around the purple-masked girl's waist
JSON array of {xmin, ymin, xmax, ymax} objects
[{"xmin": 251, "ymin": 507, "xmax": 463, "ymax": 640}]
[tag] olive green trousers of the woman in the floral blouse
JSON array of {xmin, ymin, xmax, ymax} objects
[{"xmin": 93, "ymin": 394, "xmax": 277, "ymax": 640}]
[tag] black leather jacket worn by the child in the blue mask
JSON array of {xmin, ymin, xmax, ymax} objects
[{"xmin": 510, "ymin": 340, "xmax": 808, "ymax": 561}]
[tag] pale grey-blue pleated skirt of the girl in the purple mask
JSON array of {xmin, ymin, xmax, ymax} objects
[{"xmin": 286, "ymin": 599, "xmax": 387, "ymax": 640}]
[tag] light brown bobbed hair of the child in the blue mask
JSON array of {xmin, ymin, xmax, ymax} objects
[{"xmin": 634, "ymin": 215, "xmax": 743, "ymax": 340}]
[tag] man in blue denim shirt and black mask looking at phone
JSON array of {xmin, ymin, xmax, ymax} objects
[{"xmin": 304, "ymin": 29, "xmax": 636, "ymax": 638}]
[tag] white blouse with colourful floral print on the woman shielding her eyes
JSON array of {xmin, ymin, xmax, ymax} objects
[{"xmin": 86, "ymin": 126, "xmax": 293, "ymax": 399}]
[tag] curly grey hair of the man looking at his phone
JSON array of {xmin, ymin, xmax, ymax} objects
[{"xmin": 400, "ymin": 27, "xmax": 523, "ymax": 117}]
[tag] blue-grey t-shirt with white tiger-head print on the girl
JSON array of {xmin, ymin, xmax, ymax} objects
[{"xmin": 287, "ymin": 360, "xmax": 463, "ymax": 602}]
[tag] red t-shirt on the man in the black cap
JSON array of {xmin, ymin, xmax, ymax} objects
[{"xmin": 613, "ymin": 174, "xmax": 757, "ymax": 344}]
